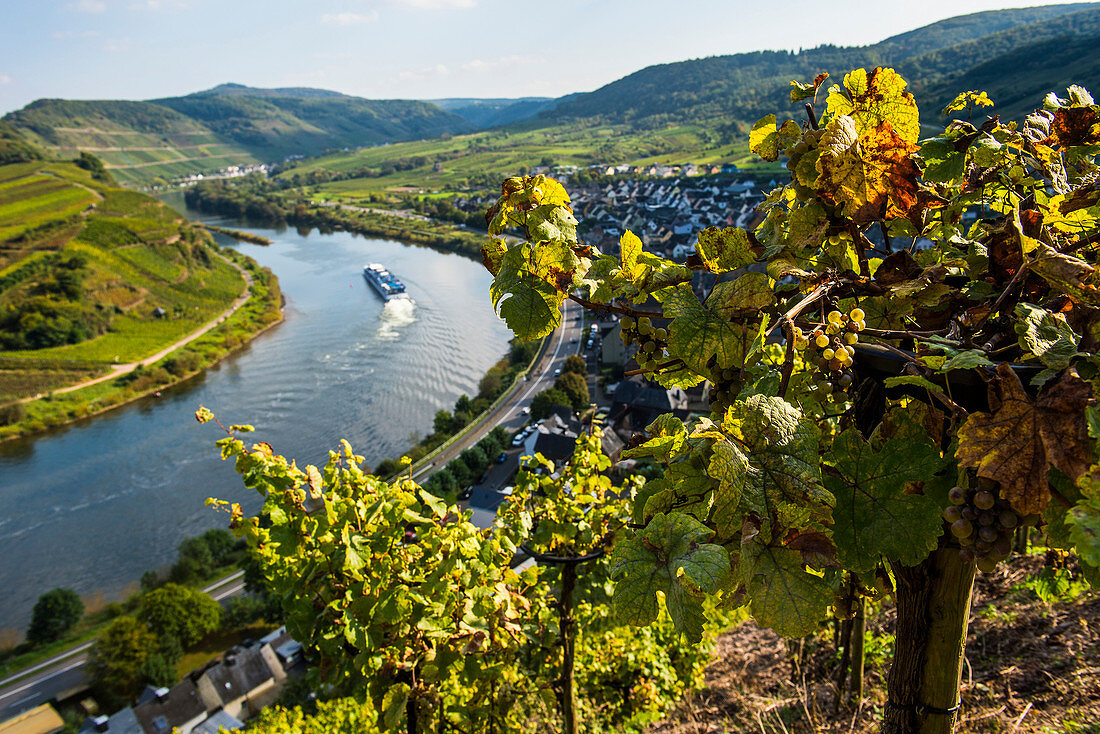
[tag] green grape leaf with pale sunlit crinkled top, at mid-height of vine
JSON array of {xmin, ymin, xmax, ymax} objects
[{"xmin": 715, "ymin": 395, "xmax": 834, "ymax": 537}]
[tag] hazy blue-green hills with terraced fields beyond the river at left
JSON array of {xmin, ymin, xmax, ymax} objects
[{"xmin": 3, "ymin": 85, "xmax": 473, "ymax": 185}]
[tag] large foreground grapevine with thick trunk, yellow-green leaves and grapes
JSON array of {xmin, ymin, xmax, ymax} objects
[{"xmin": 483, "ymin": 68, "xmax": 1100, "ymax": 734}]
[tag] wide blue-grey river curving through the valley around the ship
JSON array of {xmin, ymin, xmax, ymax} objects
[{"xmin": 0, "ymin": 200, "xmax": 510, "ymax": 628}]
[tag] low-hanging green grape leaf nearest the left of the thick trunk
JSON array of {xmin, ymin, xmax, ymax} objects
[{"xmin": 740, "ymin": 543, "xmax": 834, "ymax": 637}]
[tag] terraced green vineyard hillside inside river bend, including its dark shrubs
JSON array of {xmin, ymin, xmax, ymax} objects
[{"xmin": 0, "ymin": 154, "xmax": 244, "ymax": 405}]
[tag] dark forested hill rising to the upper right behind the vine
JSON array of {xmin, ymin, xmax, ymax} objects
[{"xmin": 542, "ymin": 3, "xmax": 1100, "ymax": 122}]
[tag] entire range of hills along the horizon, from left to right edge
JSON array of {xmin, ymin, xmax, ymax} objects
[{"xmin": 3, "ymin": 2, "xmax": 1100, "ymax": 185}]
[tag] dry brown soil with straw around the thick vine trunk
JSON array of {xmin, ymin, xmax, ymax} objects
[{"xmin": 649, "ymin": 556, "xmax": 1100, "ymax": 734}]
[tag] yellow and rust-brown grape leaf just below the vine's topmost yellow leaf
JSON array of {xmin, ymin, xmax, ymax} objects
[{"xmin": 817, "ymin": 116, "xmax": 921, "ymax": 223}]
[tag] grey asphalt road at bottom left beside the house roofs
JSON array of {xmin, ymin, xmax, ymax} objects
[{"xmin": 0, "ymin": 571, "xmax": 244, "ymax": 722}]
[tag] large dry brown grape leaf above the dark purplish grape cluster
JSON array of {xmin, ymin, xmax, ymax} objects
[{"xmin": 955, "ymin": 364, "xmax": 1092, "ymax": 515}]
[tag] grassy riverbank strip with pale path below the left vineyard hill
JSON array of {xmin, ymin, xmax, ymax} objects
[{"xmin": 0, "ymin": 250, "xmax": 283, "ymax": 441}]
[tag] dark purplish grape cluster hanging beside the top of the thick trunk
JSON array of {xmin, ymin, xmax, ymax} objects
[{"xmin": 944, "ymin": 478, "xmax": 1021, "ymax": 573}]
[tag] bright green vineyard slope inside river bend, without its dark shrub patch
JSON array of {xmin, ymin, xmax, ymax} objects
[{"xmin": 0, "ymin": 162, "xmax": 244, "ymax": 403}]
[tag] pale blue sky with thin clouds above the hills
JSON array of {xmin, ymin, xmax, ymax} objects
[{"xmin": 0, "ymin": 0, "xmax": 1091, "ymax": 114}]
